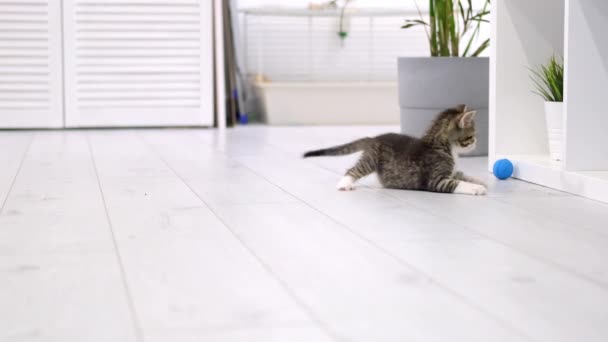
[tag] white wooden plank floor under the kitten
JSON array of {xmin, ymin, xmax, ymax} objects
[{"xmin": 0, "ymin": 126, "xmax": 608, "ymax": 342}]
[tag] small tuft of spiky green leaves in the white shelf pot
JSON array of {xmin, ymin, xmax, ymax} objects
[{"xmin": 530, "ymin": 56, "xmax": 564, "ymax": 102}]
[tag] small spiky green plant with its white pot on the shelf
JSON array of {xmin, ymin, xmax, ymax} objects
[{"xmin": 530, "ymin": 56, "xmax": 564, "ymax": 160}]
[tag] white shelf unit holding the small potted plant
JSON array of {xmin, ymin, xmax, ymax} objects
[{"xmin": 489, "ymin": 0, "xmax": 608, "ymax": 202}]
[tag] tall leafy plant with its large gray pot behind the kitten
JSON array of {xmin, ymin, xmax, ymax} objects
[{"xmin": 398, "ymin": 0, "xmax": 490, "ymax": 155}]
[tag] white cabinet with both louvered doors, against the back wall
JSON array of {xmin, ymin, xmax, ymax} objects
[{"xmin": 0, "ymin": 0, "xmax": 214, "ymax": 128}]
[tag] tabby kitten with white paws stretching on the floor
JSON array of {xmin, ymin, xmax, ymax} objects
[{"xmin": 304, "ymin": 105, "xmax": 487, "ymax": 195}]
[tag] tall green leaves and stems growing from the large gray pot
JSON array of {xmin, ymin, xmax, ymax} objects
[{"xmin": 401, "ymin": 0, "xmax": 490, "ymax": 57}]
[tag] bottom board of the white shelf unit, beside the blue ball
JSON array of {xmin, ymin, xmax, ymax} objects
[{"xmin": 497, "ymin": 154, "xmax": 608, "ymax": 203}]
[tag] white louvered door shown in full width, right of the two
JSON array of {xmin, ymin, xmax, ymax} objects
[{"xmin": 63, "ymin": 0, "xmax": 213, "ymax": 127}]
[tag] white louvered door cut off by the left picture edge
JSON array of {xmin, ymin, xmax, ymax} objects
[{"xmin": 0, "ymin": 0, "xmax": 63, "ymax": 128}]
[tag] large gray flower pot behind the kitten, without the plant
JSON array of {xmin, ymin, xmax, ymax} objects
[{"xmin": 398, "ymin": 57, "xmax": 490, "ymax": 156}]
